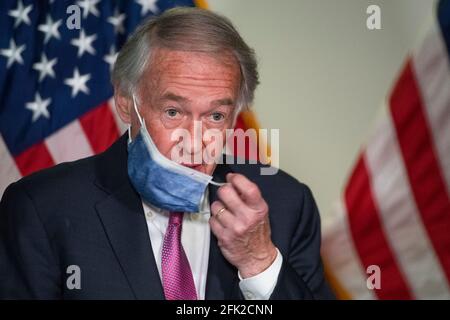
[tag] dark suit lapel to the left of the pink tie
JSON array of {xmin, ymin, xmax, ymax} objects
[{"xmin": 95, "ymin": 137, "xmax": 164, "ymax": 300}]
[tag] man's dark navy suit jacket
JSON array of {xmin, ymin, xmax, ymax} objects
[{"xmin": 0, "ymin": 136, "xmax": 332, "ymax": 299}]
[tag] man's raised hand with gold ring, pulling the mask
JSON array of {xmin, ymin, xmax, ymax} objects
[{"xmin": 209, "ymin": 173, "xmax": 277, "ymax": 278}]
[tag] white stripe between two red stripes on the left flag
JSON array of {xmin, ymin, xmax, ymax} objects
[{"xmin": 45, "ymin": 120, "xmax": 94, "ymax": 163}]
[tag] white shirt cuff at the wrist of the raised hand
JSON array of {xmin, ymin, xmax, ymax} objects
[{"xmin": 238, "ymin": 248, "xmax": 283, "ymax": 300}]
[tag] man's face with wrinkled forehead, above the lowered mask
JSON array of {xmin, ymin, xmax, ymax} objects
[{"xmin": 131, "ymin": 49, "xmax": 240, "ymax": 175}]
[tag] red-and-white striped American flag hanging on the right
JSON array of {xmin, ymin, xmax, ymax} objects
[{"xmin": 322, "ymin": 0, "xmax": 450, "ymax": 299}]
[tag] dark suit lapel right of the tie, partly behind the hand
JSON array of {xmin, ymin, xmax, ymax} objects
[{"xmin": 205, "ymin": 164, "xmax": 241, "ymax": 300}]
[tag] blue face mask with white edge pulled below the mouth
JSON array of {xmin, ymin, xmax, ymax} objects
[{"xmin": 128, "ymin": 95, "xmax": 223, "ymax": 212}]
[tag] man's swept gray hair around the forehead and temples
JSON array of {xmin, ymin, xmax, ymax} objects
[{"xmin": 111, "ymin": 7, "xmax": 259, "ymax": 111}]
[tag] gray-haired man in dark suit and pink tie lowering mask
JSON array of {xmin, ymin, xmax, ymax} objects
[{"xmin": 0, "ymin": 8, "xmax": 332, "ymax": 299}]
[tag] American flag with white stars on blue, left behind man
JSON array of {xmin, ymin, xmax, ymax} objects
[{"xmin": 0, "ymin": 0, "xmax": 203, "ymax": 196}]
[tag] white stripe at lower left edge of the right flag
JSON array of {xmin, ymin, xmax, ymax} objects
[{"xmin": 322, "ymin": 201, "xmax": 376, "ymax": 300}]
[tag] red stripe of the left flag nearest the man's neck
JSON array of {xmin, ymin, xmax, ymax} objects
[{"xmin": 79, "ymin": 102, "xmax": 119, "ymax": 153}]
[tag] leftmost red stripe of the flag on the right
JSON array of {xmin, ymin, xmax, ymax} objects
[{"xmin": 345, "ymin": 156, "xmax": 412, "ymax": 299}]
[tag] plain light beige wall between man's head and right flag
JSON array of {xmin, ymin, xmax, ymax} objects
[{"xmin": 208, "ymin": 0, "xmax": 434, "ymax": 217}]
